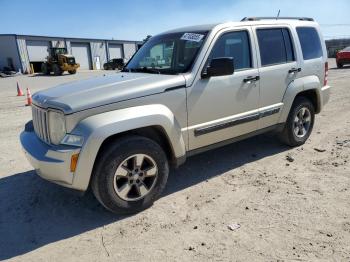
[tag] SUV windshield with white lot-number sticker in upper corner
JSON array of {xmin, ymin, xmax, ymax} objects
[{"xmin": 123, "ymin": 31, "xmax": 207, "ymax": 74}]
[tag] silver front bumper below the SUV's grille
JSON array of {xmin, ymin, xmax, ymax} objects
[{"xmin": 20, "ymin": 131, "xmax": 80, "ymax": 188}]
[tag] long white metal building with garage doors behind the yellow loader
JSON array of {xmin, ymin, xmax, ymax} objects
[{"xmin": 0, "ymin": 34, "xmax": 141, "ymax": 73}]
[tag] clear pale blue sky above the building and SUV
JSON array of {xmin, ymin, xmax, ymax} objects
[{"xmin": 0, "ymin": 0, "xmax": 350, "ymax": 40}]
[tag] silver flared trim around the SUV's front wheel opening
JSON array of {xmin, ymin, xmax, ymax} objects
[{"xmin": 71, "ymin": 104, "xmax": 186, "ymax": 191}]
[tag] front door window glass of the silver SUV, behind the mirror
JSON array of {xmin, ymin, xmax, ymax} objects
[{"xmin": 209, "ymin": 31, "xmax": 252, "ymax": 70}]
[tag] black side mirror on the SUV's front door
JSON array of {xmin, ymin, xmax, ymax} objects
[{"xmin": 202, "ymin": 57, "xmax": 235, "ymax": 78}]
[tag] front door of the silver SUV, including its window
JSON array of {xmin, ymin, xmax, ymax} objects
[{"xmin": 186, "ymin": 28, "xmax": 259, "ymax": 150}]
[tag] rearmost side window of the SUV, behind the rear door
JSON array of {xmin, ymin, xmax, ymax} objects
[{"xmin": 297, "ymin": 27, "xmax": 323, "ymax": 60}]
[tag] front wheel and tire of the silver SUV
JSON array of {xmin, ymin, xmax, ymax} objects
[{"xmin": 91, "ymin": 136, "xmax": 169, "ymax": 214}]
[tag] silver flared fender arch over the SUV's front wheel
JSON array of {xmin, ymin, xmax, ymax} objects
[{"xmin": 72, "ymin": 105, "xmax": 186, "ymax": 191}]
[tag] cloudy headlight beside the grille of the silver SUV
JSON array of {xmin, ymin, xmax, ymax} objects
[{"xmin": 49, "ymin": 111, "xmax": 66, "ymax": 145}]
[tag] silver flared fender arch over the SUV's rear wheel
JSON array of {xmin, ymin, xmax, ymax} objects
[{"xmin": 279, "ymin": 76, "xmax": 322, "ymax": 123}]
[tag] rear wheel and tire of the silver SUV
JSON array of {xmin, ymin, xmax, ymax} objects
[{"xmin": 279, "ymin": 96, "xmax": 315, "ymax": 147}]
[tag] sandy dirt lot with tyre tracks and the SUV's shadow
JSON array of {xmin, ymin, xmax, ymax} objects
[{"xmin": 0, "ymin": 61, "xmax": 350, "ymax": 262}]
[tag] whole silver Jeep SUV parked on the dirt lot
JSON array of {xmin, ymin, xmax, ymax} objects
[{"xmin": 20, "ymin": 18, "xmax": 330, "ymax": 213}]
